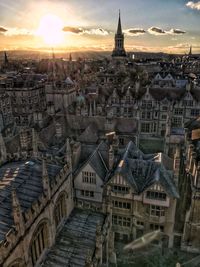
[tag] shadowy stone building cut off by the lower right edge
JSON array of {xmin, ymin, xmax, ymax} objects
[{"xmin": 175, "ymin": 118, "xmax": 200, "ymax": 253}]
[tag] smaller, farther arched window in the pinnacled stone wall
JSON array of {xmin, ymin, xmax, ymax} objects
[{"xmin": 54, "ymin": 193, "xmax": 67, "ymax": 228}]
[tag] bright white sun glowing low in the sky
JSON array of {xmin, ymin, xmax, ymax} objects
[{"xmin": 36, "ymin": 14, "xmax": 64, "ymax": 46}]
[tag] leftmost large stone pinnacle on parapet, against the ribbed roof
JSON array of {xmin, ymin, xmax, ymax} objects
[{"xmin": 12, "ymin": 189, "xmax": 25, "ymax": 236}]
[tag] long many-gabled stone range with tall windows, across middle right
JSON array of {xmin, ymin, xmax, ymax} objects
[{"xmin": 75, "ymin": 76, "xmax": 200, "ymax": 155}]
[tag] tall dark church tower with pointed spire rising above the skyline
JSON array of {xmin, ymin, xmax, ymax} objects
[{"xmin": 112, "ymin": 11, "xmax": 126, "ymax": 57}]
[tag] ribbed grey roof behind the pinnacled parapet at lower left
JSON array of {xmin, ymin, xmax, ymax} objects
[{"xmin": 0, "ymin": 160, "xmax": 62, "ymax": 241}]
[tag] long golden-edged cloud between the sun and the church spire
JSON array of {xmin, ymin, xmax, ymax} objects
[{"xmin": 63, "ymin": 26, "xmax": 109, "ymax": 35}]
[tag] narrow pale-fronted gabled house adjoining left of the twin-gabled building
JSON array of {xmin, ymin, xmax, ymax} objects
[{"xmin": 74, "ymin": 142, "xmax": 109, "ymax": 210}]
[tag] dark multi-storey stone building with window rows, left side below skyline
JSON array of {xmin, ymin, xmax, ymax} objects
[{"xmin": 0, "ymin": 74, "xmax": 46, "ymax": 126}]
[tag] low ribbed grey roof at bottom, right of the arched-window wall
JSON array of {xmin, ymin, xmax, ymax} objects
[{"xmin": 41, "ymin": 209, "xmax": 105, "ymax": 267}]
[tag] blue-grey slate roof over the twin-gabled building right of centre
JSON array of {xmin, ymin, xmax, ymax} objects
[{"xmin": 112, "ymin": 142, "xmax": 179, "ymax": 198}]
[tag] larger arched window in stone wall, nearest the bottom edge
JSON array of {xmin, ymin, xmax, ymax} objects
[{"xmin": 30, "ymin": 222, "xmax": 49, "ymax": 266}]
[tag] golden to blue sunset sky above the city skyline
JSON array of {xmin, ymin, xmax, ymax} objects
[{"xmin": 0, "ymin": 0, "xmax": 200, "ymax": 54}]
